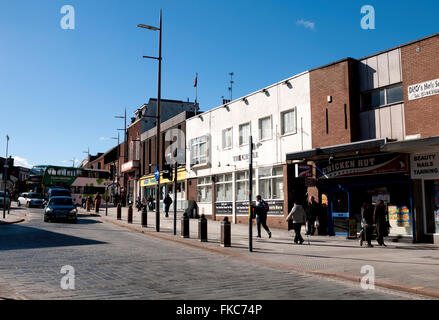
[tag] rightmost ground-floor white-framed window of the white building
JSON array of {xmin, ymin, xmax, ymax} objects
[{"xmin": 258, "ymin": 167, "xmax": 284, "ymax": 200}]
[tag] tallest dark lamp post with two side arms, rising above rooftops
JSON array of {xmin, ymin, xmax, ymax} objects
[{"xmin": 137, "ymin": 9, "xmax": 162, "ymax": 232}]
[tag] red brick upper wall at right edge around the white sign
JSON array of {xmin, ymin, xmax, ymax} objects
[{"xmin": 401, "ymin": 36, "xmax": 439, "ymax": 138}]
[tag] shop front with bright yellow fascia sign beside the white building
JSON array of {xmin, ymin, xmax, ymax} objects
[{"xmin": 140, "ymin": 168, "xmax": 186, "ymax": 211}]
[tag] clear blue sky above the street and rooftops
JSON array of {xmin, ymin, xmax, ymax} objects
[{"xmin": 0, "ymin": 0, "xmax": 439, "ymax": 169}]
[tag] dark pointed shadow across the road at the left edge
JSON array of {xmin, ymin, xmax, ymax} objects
[{"xmin": 0, "ymin": 224, "xmax": 105, "ymax": 251}]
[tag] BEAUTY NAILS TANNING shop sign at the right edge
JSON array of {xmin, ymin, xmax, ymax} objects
[{"xmin": 410, "ymin": 152, "xmax": 439, "ymax": 179}]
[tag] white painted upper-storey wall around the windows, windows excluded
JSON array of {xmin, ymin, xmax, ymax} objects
[{"xmin": 186, "ymin": 72, "xmax": 312, "ymax": 213}]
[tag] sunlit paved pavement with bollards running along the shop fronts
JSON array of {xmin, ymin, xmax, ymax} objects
[{"xmin": 95, "ymin": 204, "xmax": 439, "ymax": 298}]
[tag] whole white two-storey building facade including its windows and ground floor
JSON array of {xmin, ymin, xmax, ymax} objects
[{"xmin": 186, "ymin": 72, "xmax": 312, "ymax": 225}]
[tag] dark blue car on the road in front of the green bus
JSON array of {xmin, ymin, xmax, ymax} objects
[{"xmin": 44, "ymin": 196, "xmax": 78, "ymax": 223}]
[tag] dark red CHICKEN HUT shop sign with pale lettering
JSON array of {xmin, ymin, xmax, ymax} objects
[{"xmin": 317, "ymin": 153, "xmax": 408, "ymax": 179}]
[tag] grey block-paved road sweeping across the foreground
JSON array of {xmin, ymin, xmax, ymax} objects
[{"xmin": 0, "ymin": 205, "xmax": 430, "ymax": 300}]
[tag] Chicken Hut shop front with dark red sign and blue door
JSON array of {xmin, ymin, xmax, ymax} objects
[{"xmin": 315, "ymin": 153, "xmax": 413, "ymax": 237}]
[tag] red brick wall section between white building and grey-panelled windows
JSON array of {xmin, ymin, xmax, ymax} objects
[{"xmin": 310, "ymin": 59, "xmax": 356, "ymax": 148}]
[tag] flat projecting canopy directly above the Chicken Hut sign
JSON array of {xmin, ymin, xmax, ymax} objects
[{"xmin": 286, "ymin": 139, "xmax": 388, "ymax": 161}]
